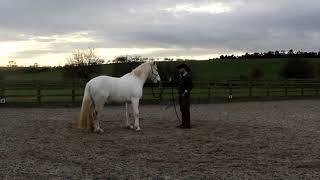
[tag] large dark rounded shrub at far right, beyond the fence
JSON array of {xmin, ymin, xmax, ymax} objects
[{"xmin": 280, "ymin": 58, "xmax": 315, "ymax": 79}]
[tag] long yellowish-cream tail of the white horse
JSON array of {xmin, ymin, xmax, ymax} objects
[{"xmin": 79, "ymin": 84, "xmax": 95, "ymax": 130}]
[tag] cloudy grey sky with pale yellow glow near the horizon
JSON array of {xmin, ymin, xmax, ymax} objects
[{"xmin": 0, "ymin": 0, "xmax": 320, "ymax": 65}]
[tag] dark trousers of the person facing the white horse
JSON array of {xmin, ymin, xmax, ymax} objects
[{"xmin": 179, "ymin": 95, "xmax": 191, "ymax": 128}]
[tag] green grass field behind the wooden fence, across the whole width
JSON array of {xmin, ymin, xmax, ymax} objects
[{"xmin": 0, "ymin": 59, "xmax": 320, "ymax": 103}]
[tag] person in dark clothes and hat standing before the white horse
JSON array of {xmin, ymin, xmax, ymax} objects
[{"xmin": 176, "ymin": 64, "xmax": 193, "ymax": 129}]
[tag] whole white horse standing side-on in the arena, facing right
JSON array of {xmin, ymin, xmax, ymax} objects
[{"xmin": 79, "ymin": 62, "xmax": 161, "ymax": 133}]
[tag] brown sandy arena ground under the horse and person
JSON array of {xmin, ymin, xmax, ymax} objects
[{"xmin": 0, "ymin": 100, "xmax": 320, "ymax": 179}]
